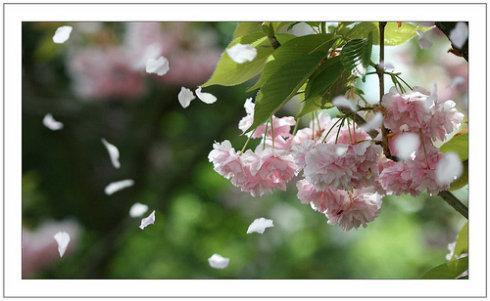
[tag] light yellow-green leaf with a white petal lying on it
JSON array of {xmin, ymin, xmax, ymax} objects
[{"xmin": 202, "ymin": 32, "xmax": 274, "ymax": 87}]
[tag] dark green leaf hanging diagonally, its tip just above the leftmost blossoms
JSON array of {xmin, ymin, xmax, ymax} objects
[{"xmin": 250, "ymin": 51, "xmax": 326, "ymax": 130}]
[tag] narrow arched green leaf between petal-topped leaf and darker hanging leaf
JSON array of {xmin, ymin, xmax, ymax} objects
[{"xmin": 247, "ymin": 34, "xmax": 334, "ymax": 92}]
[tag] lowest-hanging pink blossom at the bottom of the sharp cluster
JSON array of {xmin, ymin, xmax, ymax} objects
[{"xmin": 325, "ymin": 189, "xmax": 382, "ymax": 231}]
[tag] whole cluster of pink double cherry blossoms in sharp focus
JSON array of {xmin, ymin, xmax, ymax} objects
[{"xmin": 209, "ymin": 84, "xmax": 463, "ymax": 230}]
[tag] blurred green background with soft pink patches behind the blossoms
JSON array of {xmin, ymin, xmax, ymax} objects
[{"xmin": 22, "ymin": 22, "xmax": 468, "ymax": 279}]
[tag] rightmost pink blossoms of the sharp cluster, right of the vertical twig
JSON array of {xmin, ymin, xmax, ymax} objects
[{"xmin": 379, "ymin": 86, "xmax": 464, "ymax": 195}]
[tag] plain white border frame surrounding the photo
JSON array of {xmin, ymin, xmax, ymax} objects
[{"xmin": 3, "ymin": 3, "xmax": 487, "ymax": 297}]
